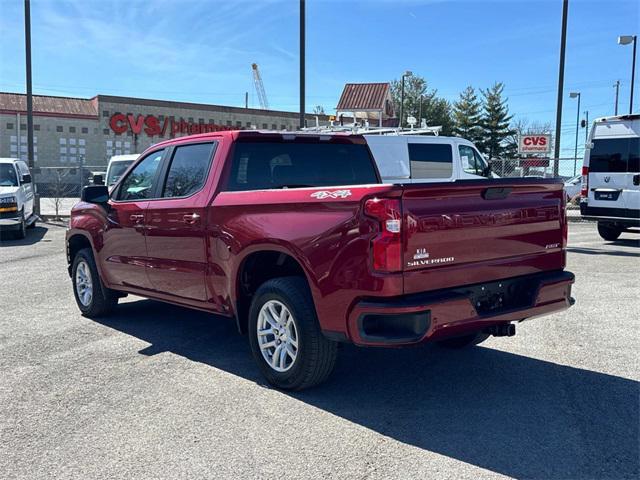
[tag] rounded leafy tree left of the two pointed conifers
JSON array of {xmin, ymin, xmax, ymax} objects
[{"xmin": 391, "ymin": 75, "xmax": 454, "ymax": 135}]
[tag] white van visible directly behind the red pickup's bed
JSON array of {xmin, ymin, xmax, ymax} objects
[{"xmin": 365, "ymin": 135, "xmax": 494, "ymax": 183}]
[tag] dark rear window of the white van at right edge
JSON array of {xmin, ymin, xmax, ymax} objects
[{"xmin": 589, "ymin": 137, "xmax": 640, "ymax": 173}]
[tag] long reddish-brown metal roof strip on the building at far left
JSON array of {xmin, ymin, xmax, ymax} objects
[{"xmin": 0, "ymin": 92, "xmax": 98, "ymax": 117}]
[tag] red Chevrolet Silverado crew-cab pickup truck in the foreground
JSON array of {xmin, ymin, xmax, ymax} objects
[{"xmin": 66, "ymin": 131, "xmax": 574, "ymax": 390}]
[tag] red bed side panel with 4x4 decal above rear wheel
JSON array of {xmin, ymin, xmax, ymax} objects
[{"xmin": 207, "ymin": 185, "xmax": 402, "ymax": 332}]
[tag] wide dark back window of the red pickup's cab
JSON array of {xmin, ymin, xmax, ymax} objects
[{"xmin": 227, "ymin": 142, "xmax": 378, "ymax": 191}]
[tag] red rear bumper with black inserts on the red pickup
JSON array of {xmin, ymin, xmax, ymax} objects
[{"xmin": 348, "ymin": 271, "xmax": 574, "ymax": 346}]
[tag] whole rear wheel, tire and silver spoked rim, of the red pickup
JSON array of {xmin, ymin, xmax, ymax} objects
[{"xmin": 249, "ymin": 277, "xmax": 337, "ymax": 390}]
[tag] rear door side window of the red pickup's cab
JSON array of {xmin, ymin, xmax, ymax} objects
[{"xmin": 162, "ymin": 143, "xmax": 214, "ymax": 197}]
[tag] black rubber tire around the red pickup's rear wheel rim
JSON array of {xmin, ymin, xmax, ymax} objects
[{"xmin": 248, "ymin": 277, "xmax": 337, "ymax": 390}]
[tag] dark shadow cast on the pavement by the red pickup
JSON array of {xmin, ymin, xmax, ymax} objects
[{"xmin": 92, "ymin": 300, "xmax": 640, "ymax": 479}]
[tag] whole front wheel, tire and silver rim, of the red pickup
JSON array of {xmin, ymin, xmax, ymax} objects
[{"xmin": 71, "ymin": 248, "xmax": 118, "ymax": 318}]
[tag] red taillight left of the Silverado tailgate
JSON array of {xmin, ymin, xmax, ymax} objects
[{"xmin": 364, "ymin": 198, "xmax": 402, "ymax": 272}]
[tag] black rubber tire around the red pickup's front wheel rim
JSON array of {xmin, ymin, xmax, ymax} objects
[{"xmin": 71, "ymin": 248, "xmax": 118, "ymax": 318}]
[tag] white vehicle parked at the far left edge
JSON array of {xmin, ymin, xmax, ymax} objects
[{"xmin": 0, "ymin": 158, "xmax": 37, "ymax": 238}]
